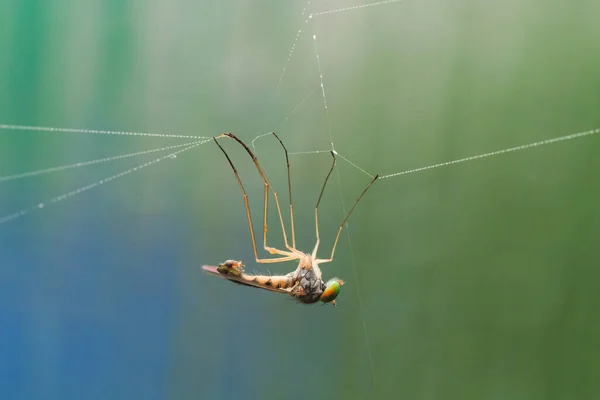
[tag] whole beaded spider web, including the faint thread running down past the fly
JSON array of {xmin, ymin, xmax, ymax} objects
[{"xmin": 0, "ymin": 0, "xmax": 600, "ymax": 396}]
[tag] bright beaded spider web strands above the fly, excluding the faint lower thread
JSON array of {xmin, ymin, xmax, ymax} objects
[{"xmin": 0, "ymin": 0, "xmax": 600, "ymax": 224}]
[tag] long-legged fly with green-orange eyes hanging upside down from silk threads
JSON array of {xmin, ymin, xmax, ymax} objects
[{"xmin": 202, "ymin": 132, "xmax": 378, "ymax": 305}]
